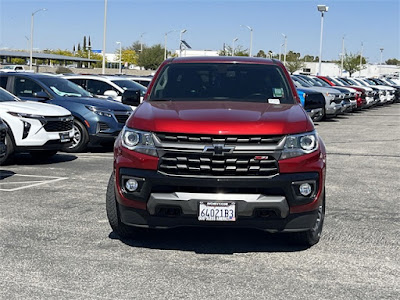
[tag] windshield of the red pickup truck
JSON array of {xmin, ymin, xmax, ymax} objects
[{"xmin": 149, "ymin": 63, "xmax": 296, "ymax": 104}]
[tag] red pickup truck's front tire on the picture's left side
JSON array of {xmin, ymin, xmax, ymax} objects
[{"xmin": 106, "ymin": 175, "xmax": 140, "ymax": 238}]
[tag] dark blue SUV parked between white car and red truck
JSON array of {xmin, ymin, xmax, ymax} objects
[{"xmin": 0, "ymin": 73, "xmax": 132, "ymax": 152}]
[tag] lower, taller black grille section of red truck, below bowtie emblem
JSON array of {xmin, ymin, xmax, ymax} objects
[{"xmin": 159, "ymin": 153, "xmax": 279, "ymax": 176}]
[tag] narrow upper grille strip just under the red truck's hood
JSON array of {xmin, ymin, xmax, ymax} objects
[{"xmin": 157, "ymin": 133, "xmax": 284, "ymax": 145}]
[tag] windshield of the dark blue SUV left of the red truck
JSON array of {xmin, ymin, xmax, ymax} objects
[{"xmin": 41, "ymin": 77, "xmax": 92, "ymax": 97}]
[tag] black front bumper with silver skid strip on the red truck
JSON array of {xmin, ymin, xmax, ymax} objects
[{"xmin": 116, "ymin": 168, "xmax": 324, "ymax": 231}]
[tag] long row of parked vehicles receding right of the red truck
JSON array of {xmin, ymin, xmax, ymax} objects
[{"xmin": 292, "ymin": 75, "xmax": 400, "ymax": 121}]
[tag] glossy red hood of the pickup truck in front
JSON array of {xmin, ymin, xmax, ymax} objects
[{"xmin": 127, "ymin": 101, "xmax": 314, "ymax": 135}]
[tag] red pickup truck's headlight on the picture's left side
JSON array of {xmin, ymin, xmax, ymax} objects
[{"xmin": 121, "ymin": 126, "xmax": 158, "ymax": 156}]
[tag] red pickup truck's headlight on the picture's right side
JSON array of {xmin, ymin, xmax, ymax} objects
[{"xmin": 280, "ymin": 131, "xmax": 318, "ymax": 159}]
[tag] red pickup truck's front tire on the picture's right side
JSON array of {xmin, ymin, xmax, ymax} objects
[{"xmin": 291, "ymin": 196, "xmax": 325, "ymax": 247}]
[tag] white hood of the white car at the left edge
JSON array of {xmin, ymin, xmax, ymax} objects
[{"xmin": 0, "ymin": 101, "xmax": 71, "ymax": 117}]
